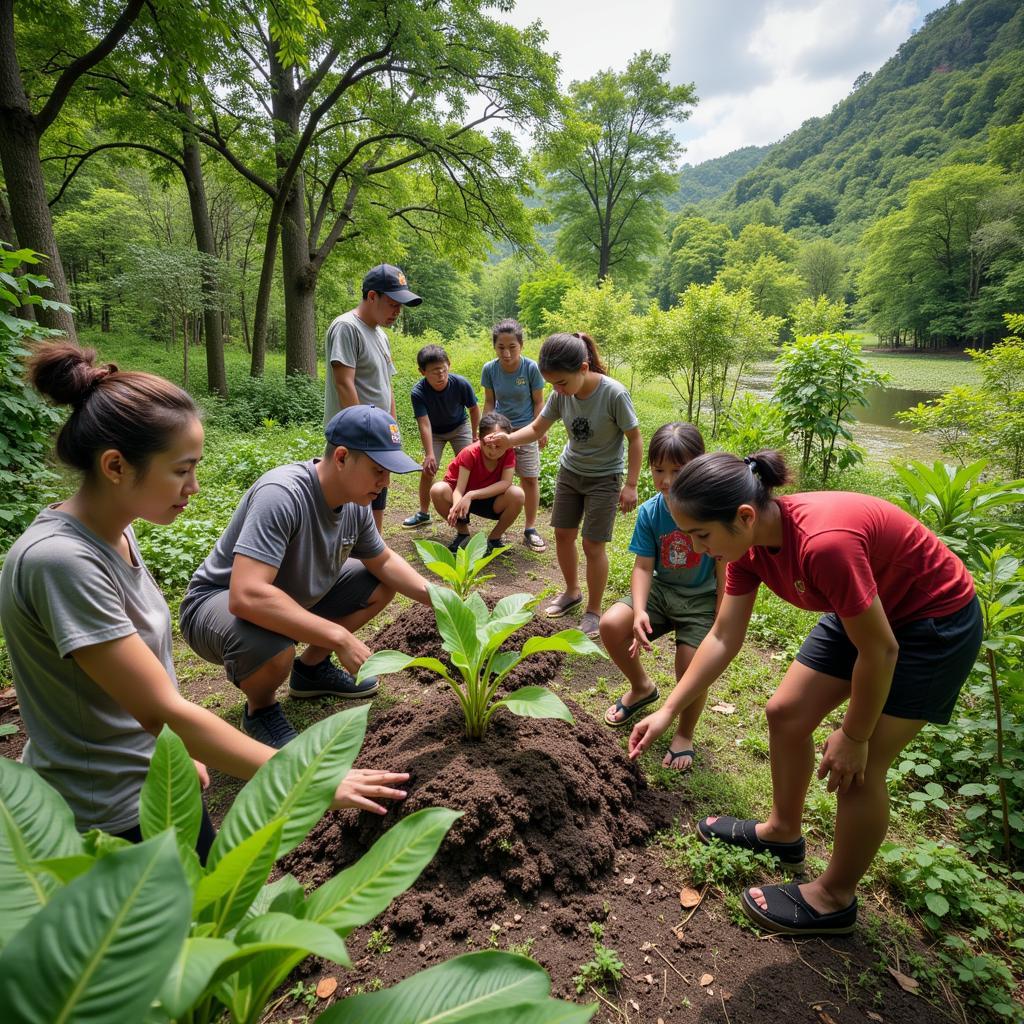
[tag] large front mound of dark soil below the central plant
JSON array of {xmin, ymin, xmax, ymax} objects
[{"xmin": 281, "ymin": 691, "xmax": 651, "ymax": 935}]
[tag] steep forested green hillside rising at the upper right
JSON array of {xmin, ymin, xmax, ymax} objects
[{"xmin": 705, "ymin": 0, "xmax": 1024, "ymax": 242}]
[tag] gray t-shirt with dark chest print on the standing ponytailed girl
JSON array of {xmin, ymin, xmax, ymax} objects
[{"xmin": 541, "ymin": 374, "xmax": 640, "ymax": 476}]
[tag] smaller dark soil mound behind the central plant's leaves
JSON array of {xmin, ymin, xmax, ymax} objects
[{"xmin": 369, "ymin": 597, "xmax": 574, "ymax": 690}]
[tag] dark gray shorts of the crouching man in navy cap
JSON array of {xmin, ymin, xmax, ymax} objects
[{"xmin": 181, "ymin": 558, "xmax": 380, "ymax": 686}]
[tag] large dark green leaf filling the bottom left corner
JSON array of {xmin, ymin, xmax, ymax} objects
[{"xmin": 0, "ymin": 831, "xmax": 191, "ymax": 1024}]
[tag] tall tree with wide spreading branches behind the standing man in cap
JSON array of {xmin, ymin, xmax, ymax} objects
[{"xmin": 191, "ymin": 0, "xmax": 557, "ymax": 375}]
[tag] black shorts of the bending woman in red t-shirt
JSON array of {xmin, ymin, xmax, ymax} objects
[{"xmin": 797, "ymin": 597, "xmax": 983, "ymax": 725}]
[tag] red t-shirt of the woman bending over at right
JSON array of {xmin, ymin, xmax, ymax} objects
[{"xmin": 725, "ymin": 492, "xmax": 974, "ymax": 627}]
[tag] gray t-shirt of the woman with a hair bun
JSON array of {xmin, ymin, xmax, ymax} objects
[{"xmin": 0, "ymin": 509, "xmax": 177, "ymax": 833}]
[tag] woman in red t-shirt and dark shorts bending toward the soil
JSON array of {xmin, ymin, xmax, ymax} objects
[{"xmin": 630, "ymin": 452, "xmax": 982, "ymax": 935}]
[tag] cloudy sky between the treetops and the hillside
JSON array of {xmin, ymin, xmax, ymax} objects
[{"xmin": 508, "ymin": 0, "xmax": 944, "ymax": 164}]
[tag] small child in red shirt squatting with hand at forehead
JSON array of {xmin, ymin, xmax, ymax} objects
[{"xmin": 430, "ymin": 413, "xmax": 526, "ymax": 555}]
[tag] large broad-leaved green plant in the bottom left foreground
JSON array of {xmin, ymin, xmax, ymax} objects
[{"xmin": 0, "ymin": 709, "xmax": 594, "ymax": 1024}]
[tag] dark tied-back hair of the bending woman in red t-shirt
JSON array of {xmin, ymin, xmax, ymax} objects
[{"xmin": 669, "ymin": 451, "xmax": 793, "ymax": 525}]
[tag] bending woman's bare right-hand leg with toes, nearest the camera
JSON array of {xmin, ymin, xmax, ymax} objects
[{"xmin": 751, "ymin": 715, "xmax": 927, "ymax": 913}]
